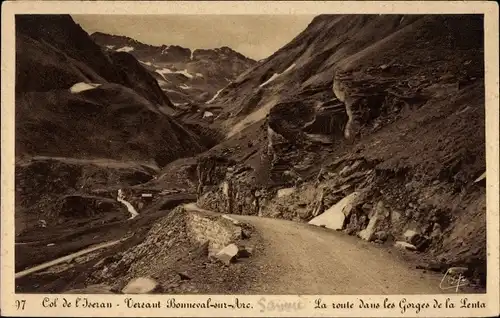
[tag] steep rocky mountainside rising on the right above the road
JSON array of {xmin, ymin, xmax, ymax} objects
[{"xmin": 199, "ymin": 15, "xmax": 486, "ymax": 282}]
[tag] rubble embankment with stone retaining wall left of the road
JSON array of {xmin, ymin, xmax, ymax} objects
[{"xmin": 87, "ymin": 206, "xmax": 255, "ymax": 293}]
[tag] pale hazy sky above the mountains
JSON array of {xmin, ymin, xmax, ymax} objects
[{"xmin": 72, "ymin": 15, "xmax": 314, "ymax": 60}]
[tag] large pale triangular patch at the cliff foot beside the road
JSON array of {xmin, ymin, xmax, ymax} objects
[{"xmin": 309, "ymin": 192, "xmax": 359, "ymax": 230}]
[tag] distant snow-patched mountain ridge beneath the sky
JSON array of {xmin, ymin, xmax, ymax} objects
[{"xmin": 90, "ymin": 32, "xmax": 257, "ymax": 105}]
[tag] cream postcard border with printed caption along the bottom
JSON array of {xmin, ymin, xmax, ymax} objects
[{"xmin": 0, "ymin": 1, "xmax": 500, "ymax": 317}]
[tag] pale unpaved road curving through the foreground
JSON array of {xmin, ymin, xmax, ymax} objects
[{"xmin": 231, "ymin": 215, "xmax": 443, "ymax": 295}]
